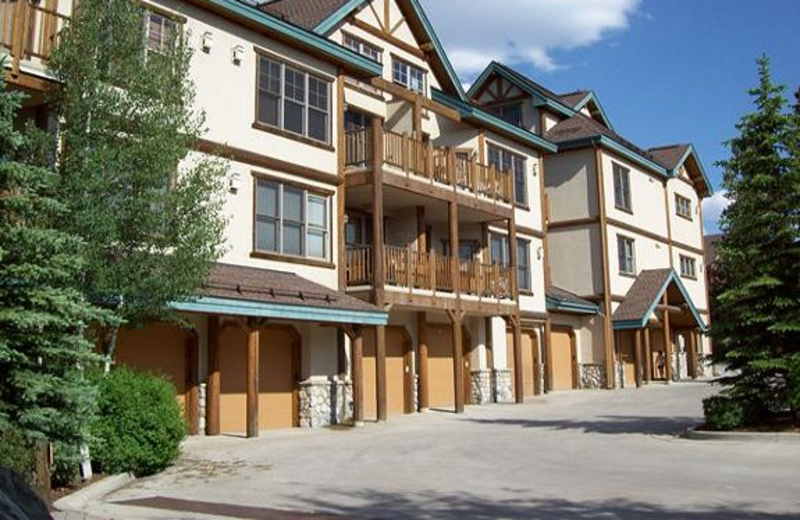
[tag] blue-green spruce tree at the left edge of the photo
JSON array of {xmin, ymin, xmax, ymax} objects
[{"xmin": 0, "ymin": 70, "xmax": 110, "ymax": 469}]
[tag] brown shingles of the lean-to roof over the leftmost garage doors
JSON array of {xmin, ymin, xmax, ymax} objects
[{"xmin": 203, "ymin": 264, "xmax": 380, "ymax": 312}]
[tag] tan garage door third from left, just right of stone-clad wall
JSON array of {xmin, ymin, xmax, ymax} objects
[{"xmin": 363, "ymin": 327, "xmax": 413, "ymax": 420}]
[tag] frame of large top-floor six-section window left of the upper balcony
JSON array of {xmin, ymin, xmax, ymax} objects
[{"xmin": 256, "ymin": 53, "xmax": 332, "ymax": 144}]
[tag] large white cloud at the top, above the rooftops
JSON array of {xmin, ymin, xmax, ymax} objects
[{"xmin": 422, "ymin": 0, "xmax": 641, "ymax": 77}]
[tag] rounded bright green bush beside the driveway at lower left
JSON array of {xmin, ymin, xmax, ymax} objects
[{"xmin": 90, "ymin": 368, "xmax": 186, "ymax": 476}]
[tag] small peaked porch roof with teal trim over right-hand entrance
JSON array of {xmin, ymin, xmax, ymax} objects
[{"xmin": 613, "ymin": 269, "xmax": 707, "ymax": 331}]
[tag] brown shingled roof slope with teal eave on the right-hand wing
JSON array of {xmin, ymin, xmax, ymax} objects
[{"xmin": 545, "ymin": 112, "xmax": 669, "ymax": 176}]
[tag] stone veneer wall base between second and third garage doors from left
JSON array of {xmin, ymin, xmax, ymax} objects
[{"xmin": 300, "ymin": 379, "xmax": 353, "ymax": 428}]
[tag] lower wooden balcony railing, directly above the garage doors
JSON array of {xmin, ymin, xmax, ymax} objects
[{"xmin": 347, "ymin": 245, "xmax": 513, "ymax": 300}]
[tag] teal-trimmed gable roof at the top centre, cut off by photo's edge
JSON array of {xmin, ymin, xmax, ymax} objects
[{"xmin": 302, "ymin": 0, "xmax": 467, "ymax": 101}]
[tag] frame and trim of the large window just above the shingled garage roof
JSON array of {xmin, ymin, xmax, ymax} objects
[{"xmin": 250, "ymin": 171, "xmax": 336, "ymax": 269}]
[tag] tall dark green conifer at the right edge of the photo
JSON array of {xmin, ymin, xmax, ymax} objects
[{"xmin": 713, "ymin": 57, "xmax": 800, "ymax": 423}]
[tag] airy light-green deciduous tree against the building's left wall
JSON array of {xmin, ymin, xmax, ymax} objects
[{"xmin": 51, "ymin": 0, "xmax": 225, "ymax": 360}]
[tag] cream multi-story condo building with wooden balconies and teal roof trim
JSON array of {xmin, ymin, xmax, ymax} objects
[{"xmin": 0, "ymin": 0, "xmax": 709, "ymax": 436}]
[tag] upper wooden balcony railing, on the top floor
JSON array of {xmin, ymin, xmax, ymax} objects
[{"xmin": 345, "ymin": 129, "xmax": 513, "ymax": 204}]
